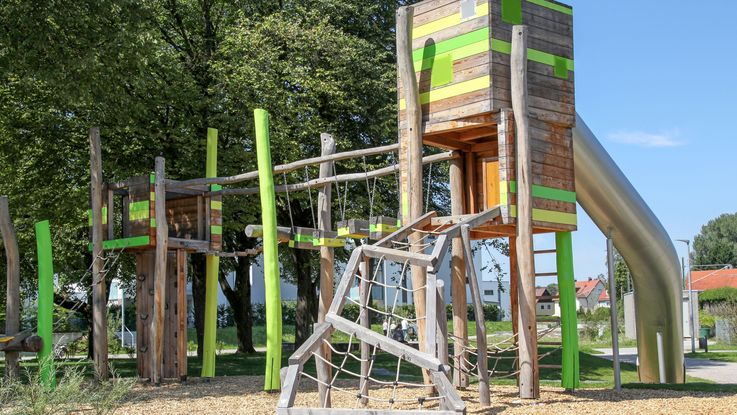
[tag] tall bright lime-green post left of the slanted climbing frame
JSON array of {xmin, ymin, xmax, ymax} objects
[{"xmin": 254, "ymin": 109, "xmax": 282, "ymax": 391}]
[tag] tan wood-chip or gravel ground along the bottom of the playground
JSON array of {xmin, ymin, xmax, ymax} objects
[{"xmin": 116, "ymin": 376, "xmax": 737, "ymax": 415}]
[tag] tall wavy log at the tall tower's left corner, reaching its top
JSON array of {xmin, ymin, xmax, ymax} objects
[{"xmin": 396, "ymin": 6, "xmax": 428, "ymax": 383}]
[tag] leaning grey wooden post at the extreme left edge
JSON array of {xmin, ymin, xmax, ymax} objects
[{"xmin": 0, "ymin": 196, "xmax": 20, "ymax": 379}]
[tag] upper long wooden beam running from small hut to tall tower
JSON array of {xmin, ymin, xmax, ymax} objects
[{"xmin": 171, "ymin": 144, "xmax": 399, "ymax": 190}]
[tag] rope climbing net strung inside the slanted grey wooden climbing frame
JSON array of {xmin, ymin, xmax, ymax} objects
[{"xmin": 301, "ymin": 257, "xmax": 446, "ymax": 410}]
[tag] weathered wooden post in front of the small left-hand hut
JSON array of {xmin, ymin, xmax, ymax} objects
[{"xmin": 151, "ymin": 157, "xmax": 169, "ymax": 385}]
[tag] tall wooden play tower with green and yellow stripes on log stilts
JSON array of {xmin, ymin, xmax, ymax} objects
[{"xmin": 397, "ymin": 0, "xmax": 577, "ymax": 398}]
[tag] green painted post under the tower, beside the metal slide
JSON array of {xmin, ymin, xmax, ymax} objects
[{"xmin": 555, "ymin": 232, "xmax": 579, "ymax": 389}]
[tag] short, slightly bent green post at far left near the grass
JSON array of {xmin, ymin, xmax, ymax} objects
[{"xmin": 36, "ymin": 220, "xmax": 56, "ymax": 388}]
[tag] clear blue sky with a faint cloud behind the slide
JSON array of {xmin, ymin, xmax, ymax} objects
[{"xmin": 520, "ymin": 0, "xmax": 737, "ymax": 283}]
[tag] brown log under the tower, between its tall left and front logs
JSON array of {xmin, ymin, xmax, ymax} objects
[{"xmin": 449, "ymin": 158, "xmax": 468, "ymax": 387}]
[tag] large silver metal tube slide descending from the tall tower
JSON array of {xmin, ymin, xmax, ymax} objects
[{"xmin": 573, "ymin": 115, "xmax": 685, "ymax": 383}]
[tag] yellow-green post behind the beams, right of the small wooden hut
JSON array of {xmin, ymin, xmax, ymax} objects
[{"xmin": 202, "ymin": 128, "xmax": 220, "ymax": 378}]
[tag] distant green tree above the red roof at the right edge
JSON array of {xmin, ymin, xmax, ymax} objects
[{"xmin": 692, "ymin": 213, "xmax": 737, "ymax": 266}]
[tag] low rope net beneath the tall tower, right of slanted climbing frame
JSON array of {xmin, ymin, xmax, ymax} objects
[{"xmin": 448, "ymin": 323, "xmax": 562, "ymax": 379}]
